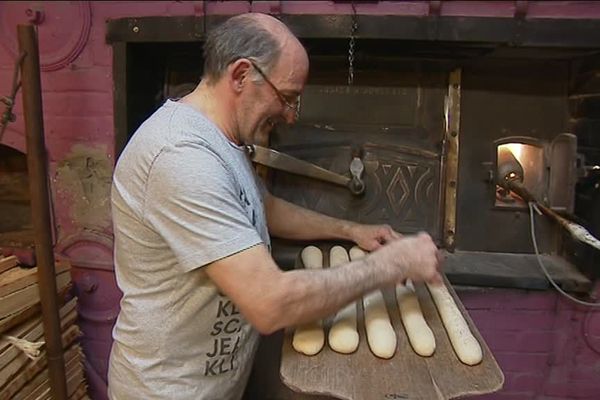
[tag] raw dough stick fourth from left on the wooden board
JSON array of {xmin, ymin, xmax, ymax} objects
[{"xmin": 396, "ymin": 280, "xmax": 435, "ymax": 357}]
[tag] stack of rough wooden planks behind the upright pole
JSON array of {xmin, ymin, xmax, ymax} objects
[{"xmin": 0, "ymin": 256, "xmax": 88, "ymax": 400}]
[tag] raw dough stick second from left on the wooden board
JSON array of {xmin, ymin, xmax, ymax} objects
[{"xmin": 329, "ymin": 246, "xmax": 359, "ymax": 354}]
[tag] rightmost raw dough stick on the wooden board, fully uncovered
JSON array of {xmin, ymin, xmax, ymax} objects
[{"xmin": 427, "ymin": 284, "xmax": 483, "ymax": 365}]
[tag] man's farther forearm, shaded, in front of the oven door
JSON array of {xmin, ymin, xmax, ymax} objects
[{"xmin": 265, "ymin": 195, "xmax": 356, "ymax": 240}]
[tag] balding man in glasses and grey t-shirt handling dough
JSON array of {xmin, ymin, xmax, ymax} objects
[{"xmin": 109, "ymin": 14, "xmax": 440, "ymax": 400}]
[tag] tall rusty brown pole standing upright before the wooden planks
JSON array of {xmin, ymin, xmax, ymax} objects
[{"xmin": 17, "ymin": 24, "xmax": 67, "ymax": 400}]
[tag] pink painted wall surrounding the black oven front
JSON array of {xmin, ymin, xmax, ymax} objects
[{"xmin": 0, "ymin": 1, "xmax": 600, "ymax": 400}]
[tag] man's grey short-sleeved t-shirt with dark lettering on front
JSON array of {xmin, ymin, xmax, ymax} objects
[{"xmin": 108, "ymin": 100, "xmax": 270, "ymax": 400}]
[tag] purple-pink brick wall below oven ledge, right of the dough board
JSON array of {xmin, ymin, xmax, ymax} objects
[{"xmin": 457, "ymin": 289, "xmax": 600, "ymax": 400}]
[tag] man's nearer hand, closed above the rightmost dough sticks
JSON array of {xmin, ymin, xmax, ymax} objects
[{"xmin": 368, "ymin": 232, "xmax": 442, "ymax": 284}]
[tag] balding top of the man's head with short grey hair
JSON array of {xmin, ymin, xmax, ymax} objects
[{"xmin": 204, "ymin": 13, "xmax": 305, "ymax": 81}]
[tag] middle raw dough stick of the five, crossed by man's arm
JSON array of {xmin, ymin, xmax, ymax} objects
[{"xmin": 350, "ymin": 246, "xmax": 397, "ymax": 359}]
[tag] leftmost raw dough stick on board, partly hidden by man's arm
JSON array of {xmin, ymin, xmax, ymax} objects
[{"xmin": 292, "ymin": 246, "xmax": 325, "ymax": 356}]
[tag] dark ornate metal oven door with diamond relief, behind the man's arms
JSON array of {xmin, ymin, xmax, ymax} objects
[{"xmin": 270, "ymin": 71, "xmax": 448, "ymax": 241}]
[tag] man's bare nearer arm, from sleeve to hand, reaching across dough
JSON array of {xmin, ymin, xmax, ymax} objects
[{"xmin": 205, "ymin": 234, "xmax": 441, "ymax": 333}]
